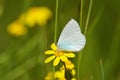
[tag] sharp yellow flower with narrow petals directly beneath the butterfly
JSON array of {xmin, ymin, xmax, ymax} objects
[{"xmin": 45, "ymin": 43, "xmax": 75, "ymax": 66}]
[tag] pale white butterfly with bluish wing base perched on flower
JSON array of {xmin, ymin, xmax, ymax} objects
[{"xmin": 57, "ymin": 19, "xmax": 86, "ymax": 52}]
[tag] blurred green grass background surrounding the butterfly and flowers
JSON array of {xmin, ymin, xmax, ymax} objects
[{"xmin": 0, "ymin": 0, "xmax": 120, "ymax": 80}]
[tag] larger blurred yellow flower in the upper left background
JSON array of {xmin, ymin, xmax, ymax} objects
[{"xmin": 19, "ymin": 7, "xmax": 52, "ymax": 27}]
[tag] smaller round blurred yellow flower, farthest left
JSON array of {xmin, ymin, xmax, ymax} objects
[{"xmin": 7, "ymin": 21, "xmax": 27, "ymax": 37}]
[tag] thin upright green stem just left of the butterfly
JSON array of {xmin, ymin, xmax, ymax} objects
[{"xmin": 52, "ymin": 0, "xmax": 58, "ymax": 80}]
